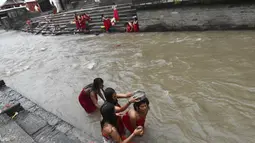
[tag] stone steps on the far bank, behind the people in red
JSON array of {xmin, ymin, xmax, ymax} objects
[{"xmin": 23, "ymin": 3, "xmax": 136, "ymax": 34}]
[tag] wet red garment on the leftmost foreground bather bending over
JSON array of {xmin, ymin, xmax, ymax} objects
[{"xmin": 79, "ymin": 89, "xmax": 98, "ymax": 113}]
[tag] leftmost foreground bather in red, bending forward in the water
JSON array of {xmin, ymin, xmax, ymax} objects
[{"xmin": 78, "ymin": 78, "xmax": 105, "ymax": 113}]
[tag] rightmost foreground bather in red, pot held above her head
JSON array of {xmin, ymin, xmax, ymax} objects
[{"xmin": 122, "ymin": 97, "xmax": 149, "ymax": 135}]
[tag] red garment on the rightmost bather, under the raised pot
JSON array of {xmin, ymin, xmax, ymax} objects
[{"xmin": 122, "ymin": 112, "xmax": 145, "ymax": 133}]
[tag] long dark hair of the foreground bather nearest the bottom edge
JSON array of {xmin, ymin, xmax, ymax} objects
[{"xmin": 100, "ymin": 102, "xmax": 118, "ymax": 129}]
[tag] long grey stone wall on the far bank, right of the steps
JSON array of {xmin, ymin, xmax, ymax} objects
[{"xmin": 137, "ymin": 4, "xmax": 255, "ymax": 31}]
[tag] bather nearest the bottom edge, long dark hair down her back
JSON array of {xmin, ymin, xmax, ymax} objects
[{"xmin": 100, "ymin": 102, "xmax": 142, "ymax": 143}]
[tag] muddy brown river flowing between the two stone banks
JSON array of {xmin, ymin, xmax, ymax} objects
[{"xmin": 0, "ymin": 31, "xmax": 255, "ymax": 143}]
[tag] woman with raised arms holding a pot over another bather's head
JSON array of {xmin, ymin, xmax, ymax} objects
[{"xmin": 104, "ymin": 88, "xmax": 136, "ymax": 136}]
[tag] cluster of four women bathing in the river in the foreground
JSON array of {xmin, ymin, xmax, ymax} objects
[{"xmin": 78, "ymin": 78, "xmax": 149, "ymax": 143}]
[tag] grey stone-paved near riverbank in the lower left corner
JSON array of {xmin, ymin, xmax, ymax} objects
[{"xmin": 0, "ymin": 82, "xmax": 101, "ymax": 143}]
